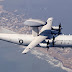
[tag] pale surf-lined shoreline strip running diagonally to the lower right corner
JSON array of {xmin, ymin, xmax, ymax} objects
[{"xmin": 31, "ymin": 49, "xmax": 72, "ymax": 72}]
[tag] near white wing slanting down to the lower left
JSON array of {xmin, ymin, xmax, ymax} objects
[{"xmin": 22, "ymin": 35, "xmax": 47, "ymax": 54}]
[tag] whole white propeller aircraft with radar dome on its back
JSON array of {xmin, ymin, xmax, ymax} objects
[{"xmin": 0, "ymin": 17, "xmax": 72, "ymax": 54}]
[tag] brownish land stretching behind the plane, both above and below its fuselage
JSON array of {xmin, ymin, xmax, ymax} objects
[{"xmin": 0, "ymin": 6, "xmax": 72, "ymax": 69}]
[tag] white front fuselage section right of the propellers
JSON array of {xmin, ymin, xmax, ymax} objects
[{"xmin": 50, "ymin": 35, "xmax": 72, "ymax": 47}]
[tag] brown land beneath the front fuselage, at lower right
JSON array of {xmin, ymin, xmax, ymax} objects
[{"xmin": 38, "ymin": 47, "xmax": 72, "ymax": 69}]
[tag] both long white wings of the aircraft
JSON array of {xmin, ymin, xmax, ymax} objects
[{"xmin": 22, "ymin": 17, "xmax": 53, "ymax": 54}]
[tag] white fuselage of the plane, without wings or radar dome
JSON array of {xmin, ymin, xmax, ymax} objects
[{"xmin": 0, "ymin": 33, "xmax": 72, "ymax": 47}]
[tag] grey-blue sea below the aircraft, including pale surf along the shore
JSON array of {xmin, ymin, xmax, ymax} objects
[{"xmin": 0, "ymin": 41, "xmax": 68, "ymax": 72}]
